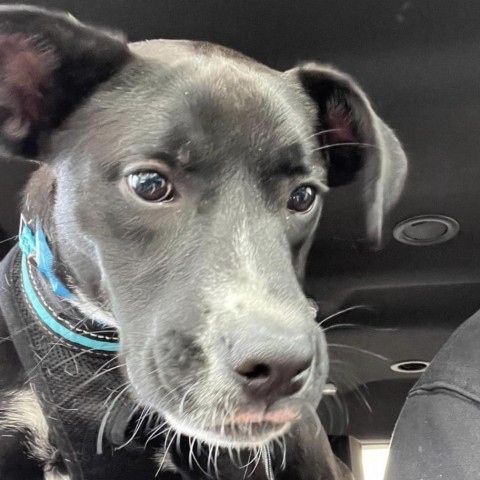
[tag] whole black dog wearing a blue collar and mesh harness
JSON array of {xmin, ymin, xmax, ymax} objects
[{"xmin": 0, "ymin": 7, "xmax": 406, "ymax": 480}]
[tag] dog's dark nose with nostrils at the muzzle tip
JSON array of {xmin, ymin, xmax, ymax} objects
[{"xmin": 230, "ymin": 332, "xmax": 313, "ymax": 405}]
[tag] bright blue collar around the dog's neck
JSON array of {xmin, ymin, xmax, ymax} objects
[{"xmin": 19, "ymin": 215, "xmax": 119, "ymax": 352}]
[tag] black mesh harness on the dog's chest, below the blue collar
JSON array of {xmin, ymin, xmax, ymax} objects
[{"xmin": 0, "ymin": 248, "xmax": 173, "ymax": 480}]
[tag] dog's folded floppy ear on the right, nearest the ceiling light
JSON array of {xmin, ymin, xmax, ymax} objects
[{"xmin": 286, "ymin": 63, "xmax": 407, "ymax": 248}]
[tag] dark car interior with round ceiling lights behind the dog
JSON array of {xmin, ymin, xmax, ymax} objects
[{"xmin": 0, "ymin": 0, "xmax": 480, "ymax": 480}]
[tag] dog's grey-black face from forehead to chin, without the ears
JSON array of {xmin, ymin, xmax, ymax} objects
[{"xmin": 51, "ymin": 50, "xmax": 327, "ymax": 442}]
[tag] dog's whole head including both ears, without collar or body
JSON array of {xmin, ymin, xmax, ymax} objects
[{"xmin": 0, "ymin": 8, "xmax": 405, "ymax": 446}]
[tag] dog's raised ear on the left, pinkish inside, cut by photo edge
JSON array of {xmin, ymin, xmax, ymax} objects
[{"xmin": 0, "ymin": 6, "xmax": 130, "ymax": 157}]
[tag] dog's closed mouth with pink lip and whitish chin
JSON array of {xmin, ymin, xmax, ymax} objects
[{"xmin": 164, "ymin": 408, "xmax": 300, "ymax": 448}]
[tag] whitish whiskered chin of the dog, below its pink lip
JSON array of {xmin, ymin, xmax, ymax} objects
[{"xmin": 163, "ymin": 413, "xmax": 293, "ymax": 449}]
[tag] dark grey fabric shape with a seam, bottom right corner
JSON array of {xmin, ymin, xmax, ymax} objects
[{"xmin": 385, "ymin": 312, "xmax": 480, "ymax": 480}]
